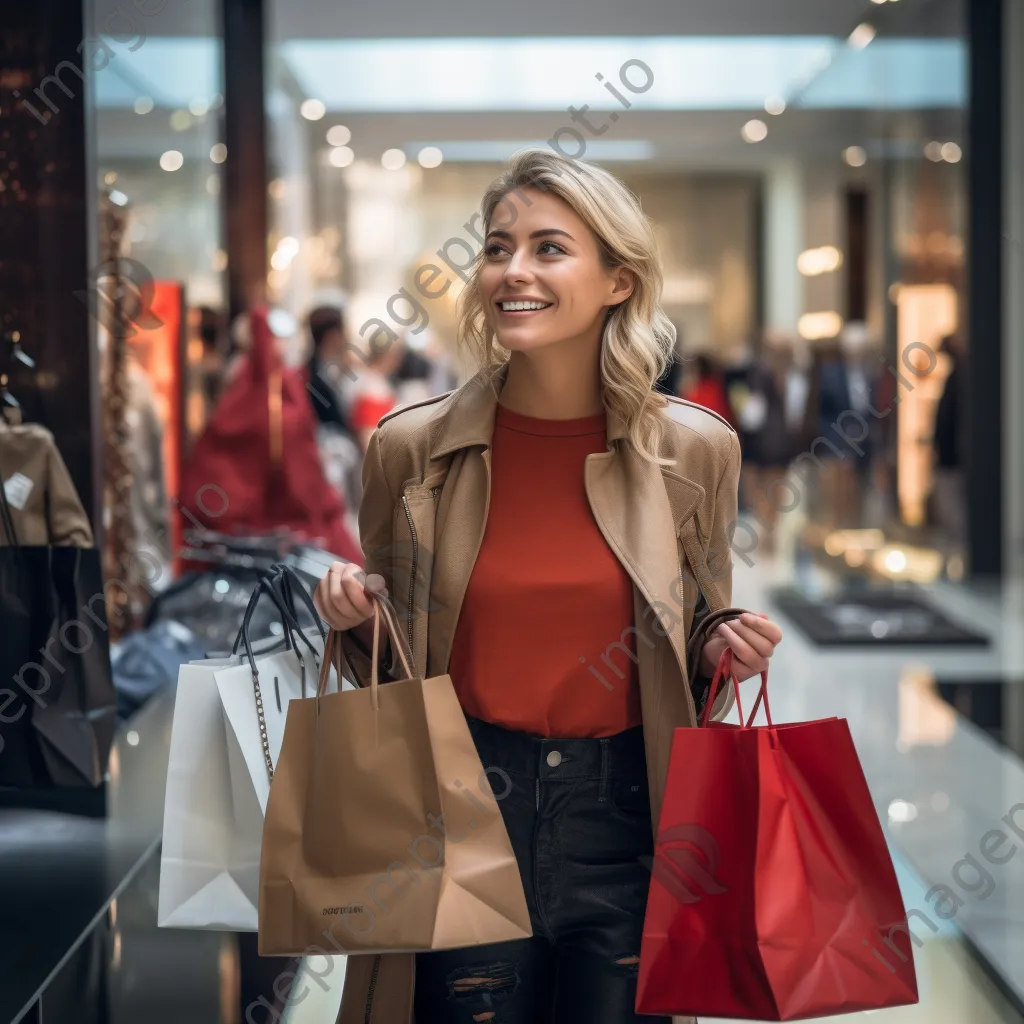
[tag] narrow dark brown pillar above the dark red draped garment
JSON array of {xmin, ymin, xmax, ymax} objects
[{"xmin": 222, "ymin": 0, "xmax": 267, "ymax": 318}]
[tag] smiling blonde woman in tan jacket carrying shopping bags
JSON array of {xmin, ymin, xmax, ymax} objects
[{"xmin": 317, "ymin": 152, "xmax": 781, "ymax": 1024}]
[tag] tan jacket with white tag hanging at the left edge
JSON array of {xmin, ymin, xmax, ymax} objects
[{"xmin": 0, "ymin": 423, "xmax": 93, "ymax": 548}]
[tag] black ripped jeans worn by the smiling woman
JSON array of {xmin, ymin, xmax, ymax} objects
[{"xmin": 416, "ymin": 717, "xmax": 670, "ymax": 1024}]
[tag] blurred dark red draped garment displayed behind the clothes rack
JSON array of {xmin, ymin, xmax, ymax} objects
[{"xmin": 180, "ymin": 309, "xmax": 362, "ymax": 565}]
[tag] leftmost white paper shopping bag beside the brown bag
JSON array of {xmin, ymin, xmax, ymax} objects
[{"xmin": 158, "ymin": 629, "xmax": 336, "ymax": 932}]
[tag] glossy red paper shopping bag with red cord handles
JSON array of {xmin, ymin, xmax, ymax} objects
[{"xmin": 636, "ymin": 650, "xmax": 918, "ymax": 1021}]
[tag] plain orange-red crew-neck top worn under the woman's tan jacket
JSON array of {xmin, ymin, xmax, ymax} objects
[{"xmin": 450, "ymin": 406, "xmax": 641, "ymax": 739}]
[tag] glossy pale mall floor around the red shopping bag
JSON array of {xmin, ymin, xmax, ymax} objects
[{"xmin": 288, "ymin": 559, "xmax": 1024, "ymax": 1024}]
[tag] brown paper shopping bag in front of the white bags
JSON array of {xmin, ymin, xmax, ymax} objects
[{"xmin": 259, "ymin": 598, "xmax": 532, "ymax": 956}]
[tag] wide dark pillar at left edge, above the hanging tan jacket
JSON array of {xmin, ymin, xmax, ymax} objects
[{"xmin": 0, "ymin": 0, "xmax": 101, "ymax": 527}]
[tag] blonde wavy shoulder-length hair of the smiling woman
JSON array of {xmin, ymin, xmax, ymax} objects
[{"xmin": 459, "ymin": 150, "xmax": 676, "ymax": 464}]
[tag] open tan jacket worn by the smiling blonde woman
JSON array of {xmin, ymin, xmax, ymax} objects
[{"xmin": 338, "ymin": 368, "xmax": 739, "ymax": 1024}]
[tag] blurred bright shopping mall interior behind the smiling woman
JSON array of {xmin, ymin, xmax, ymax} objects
[{"xmin": 0, "ymin": 0, "xmax": 1024, "ymax": 1024}]
